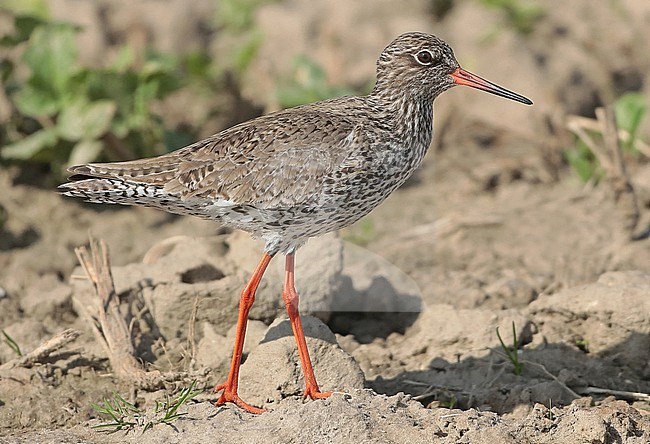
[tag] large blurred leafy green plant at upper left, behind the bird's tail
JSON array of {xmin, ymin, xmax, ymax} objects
[{"xmin": 0, "ymin": 6, "xmax": 192, "ymax": 175}]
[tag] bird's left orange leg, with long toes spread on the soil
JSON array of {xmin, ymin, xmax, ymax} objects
[{"xmin": 214, "ymin": 253, "xmax": 273, "ymax": 413}]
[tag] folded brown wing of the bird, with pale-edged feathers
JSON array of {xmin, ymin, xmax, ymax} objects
[{"xmin": 70, "ymin": 104, "xmax": 362, "ymax": 208}]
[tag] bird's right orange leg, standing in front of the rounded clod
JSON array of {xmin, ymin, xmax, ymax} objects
[{"xmin": 282, "ymin": 253, "xmax": 332, "ymax": 399}]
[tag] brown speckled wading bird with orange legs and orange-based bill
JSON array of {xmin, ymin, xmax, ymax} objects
[{"xmin": 59, "ymin": 32, "xmax": 532, "ymax": 413}]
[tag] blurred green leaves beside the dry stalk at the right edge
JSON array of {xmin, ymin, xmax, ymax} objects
[{"xmin": 564, "ymin": 92, "xmax": 648, "ymax": 182}]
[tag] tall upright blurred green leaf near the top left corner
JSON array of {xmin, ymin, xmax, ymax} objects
[{"xmin": 23, "ymin": 24, "xmax": 77, "ymax": 98}]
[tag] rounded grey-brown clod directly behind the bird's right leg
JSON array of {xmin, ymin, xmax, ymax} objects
[{"xmin": 239, "ymin": 316, "xmax": 364, "ymax": 406}]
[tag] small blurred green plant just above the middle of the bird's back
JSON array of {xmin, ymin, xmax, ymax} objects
[{"xmin": 276, "ymin": 54, "xmax": 354, "ymax": 108}]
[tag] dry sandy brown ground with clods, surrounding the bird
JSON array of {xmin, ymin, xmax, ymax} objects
[{"xmin": 0, "ymin": 0, "xmax": 650, "ymax": 443}]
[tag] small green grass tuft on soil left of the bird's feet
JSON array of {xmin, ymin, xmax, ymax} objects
[{"xmin": 91, "ymin": 381, "xmax": 201, "ymax": 433}]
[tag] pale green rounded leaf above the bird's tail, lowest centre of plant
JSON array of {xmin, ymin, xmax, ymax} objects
[{"xmin": 57, "ymin": 100, "xmax": 117, "ymax": 141}]
